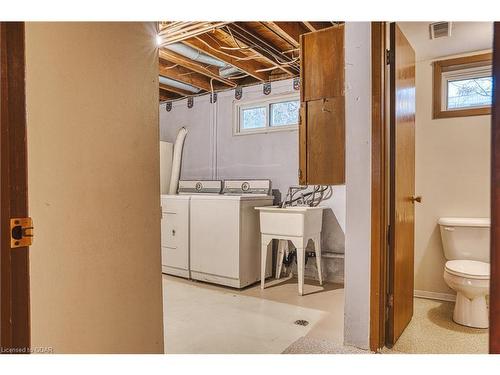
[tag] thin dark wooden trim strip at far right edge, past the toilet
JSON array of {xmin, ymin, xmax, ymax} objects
[{"xmin": 489, "ymin": 22, "xmax": 500, "ymax": 354}]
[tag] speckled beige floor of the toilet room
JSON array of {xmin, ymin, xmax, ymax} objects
[{"xmin": 383, "ymin": 298, "xmax": 488, "ymax": 354}]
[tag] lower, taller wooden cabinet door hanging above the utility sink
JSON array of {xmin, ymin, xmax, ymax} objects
[{"xmin": 306, "ymin": 96, "xmax": 345, "ymax": 185}]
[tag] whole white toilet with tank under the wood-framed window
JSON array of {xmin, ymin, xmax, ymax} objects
[{"xmin": 438, "ymin": 217, "xmax": 490, "ymax": 328}]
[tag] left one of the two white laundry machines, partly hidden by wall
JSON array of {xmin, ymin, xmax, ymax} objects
[{"xmin": 161, "ymin": 180, "xmax": 222, "ymax": 278}]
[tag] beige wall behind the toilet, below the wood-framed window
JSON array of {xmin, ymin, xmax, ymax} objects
[{"xmin": 415, "ymin": 50, "xmax": 490, "ymax": 297}]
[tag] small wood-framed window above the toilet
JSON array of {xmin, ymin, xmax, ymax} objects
[{"xmin": 433, "ymin": 54, "xmax": 493, "ymax": 118}]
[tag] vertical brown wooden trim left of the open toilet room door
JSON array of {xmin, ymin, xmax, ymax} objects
[{"xmin": 370, "ymin": 22, "xmax": 388, "ymax": 351}]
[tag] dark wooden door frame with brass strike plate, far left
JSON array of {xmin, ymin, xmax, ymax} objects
[{"xmin": 0, "ymin": 22, "xmax": 30, "ymax": 353}]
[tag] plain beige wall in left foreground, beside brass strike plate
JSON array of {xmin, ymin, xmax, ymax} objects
[{"xmin": 26, "ymin": 23, "xmax": 163, "ymax": 353}]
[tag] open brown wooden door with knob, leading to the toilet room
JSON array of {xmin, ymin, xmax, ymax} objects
[{"xmin": 387, "ymin": 23, "xmax": 415, "ymax": 346}]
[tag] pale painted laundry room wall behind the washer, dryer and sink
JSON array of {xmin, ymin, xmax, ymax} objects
[{"xmin": 160, "ymin": 80, "xmax": 345, "ymax": 253}]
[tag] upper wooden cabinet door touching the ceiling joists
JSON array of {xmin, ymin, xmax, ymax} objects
[{"xmin": 300, "ymin": 25, "xmax": 344, "ymax": 102}]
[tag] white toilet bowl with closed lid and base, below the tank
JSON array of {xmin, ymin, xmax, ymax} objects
[{"xmin": 444, "ymin": 260, "xmax": 490, "ymax": 328}]
